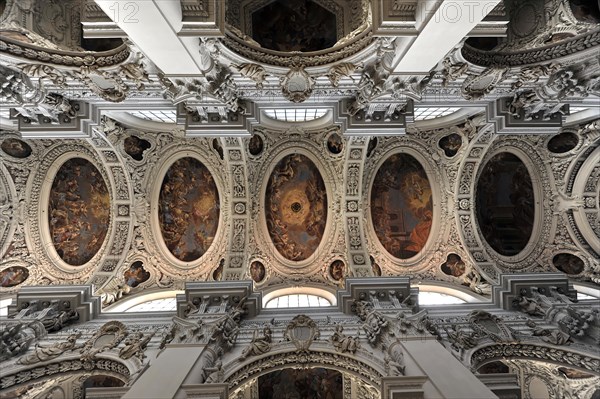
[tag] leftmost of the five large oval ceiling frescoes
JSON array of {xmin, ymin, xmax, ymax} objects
[{"xmin": 48, "ymin": 158, "xmax": 110, "ymax": 266}]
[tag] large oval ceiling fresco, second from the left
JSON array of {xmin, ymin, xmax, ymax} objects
[{"xmin": 158, "ymin": 157, "xmax": 220, "ymax": 262}]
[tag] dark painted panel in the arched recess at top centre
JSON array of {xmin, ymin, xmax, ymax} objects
[{"xmin": 252, "ymin": 0, "xmax": 338, "ymax": 51}]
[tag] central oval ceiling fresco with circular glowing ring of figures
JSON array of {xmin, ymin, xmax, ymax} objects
[{"xmin": 265, "ymin": 154, "xmax": 327, "ymax": 261}]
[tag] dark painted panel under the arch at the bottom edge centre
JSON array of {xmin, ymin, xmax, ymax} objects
[{"xmin": 258, "ymin": 368, "xmax": 344, "ymax": 399}]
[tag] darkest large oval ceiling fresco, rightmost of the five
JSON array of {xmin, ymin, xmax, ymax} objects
[{"xmin": 476, "ymin": 152, "xmax": 535, "ymax": 256}]
